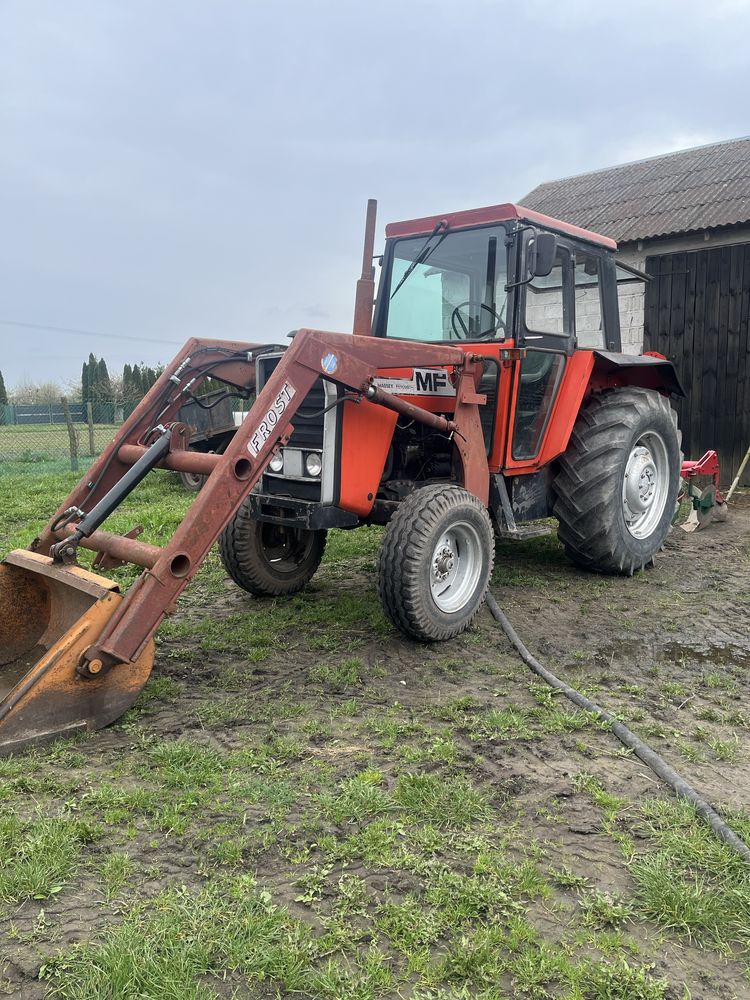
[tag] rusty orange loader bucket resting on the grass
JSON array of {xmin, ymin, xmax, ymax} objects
[{"xmin": 0, "ymin": 550, "xmax": 154, "ymax": 755}]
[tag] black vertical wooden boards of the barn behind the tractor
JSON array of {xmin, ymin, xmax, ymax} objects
[{"xmin": 643, "ymin": 243, "xmax": 750, "ymax": 485}]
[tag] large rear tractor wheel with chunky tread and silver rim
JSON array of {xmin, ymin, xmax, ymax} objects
[{"xmin": 553, "ymin": 386, "xmax": 681, "ymax": 576}]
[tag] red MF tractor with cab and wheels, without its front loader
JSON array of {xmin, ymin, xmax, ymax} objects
[{"xmin": 221, "ymin": 205, "xmax": 681, "ymax": 640}]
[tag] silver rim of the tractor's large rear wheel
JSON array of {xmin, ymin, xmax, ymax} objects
[{"xmin": 622, "ymin": 431, "xmax": 669, "ymax": 538}]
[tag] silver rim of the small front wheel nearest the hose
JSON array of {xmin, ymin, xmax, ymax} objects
[{"xmin": 429, "ymin": 521, "xmax": 482, "ymax": 615}]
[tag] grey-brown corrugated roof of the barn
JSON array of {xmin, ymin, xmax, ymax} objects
[{"xmin": 521, "ymin": 137, "xmax": 750, "ymax": 243}]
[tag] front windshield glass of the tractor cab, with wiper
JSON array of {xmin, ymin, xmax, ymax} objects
[{"xmin": 386, "ymin": 226, "xmax": 508, "ymax": 340}]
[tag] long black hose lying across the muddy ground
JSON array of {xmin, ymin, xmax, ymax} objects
[{"xmin": 487, "ymin": 594, "xmax": 750, "ymax": 862}]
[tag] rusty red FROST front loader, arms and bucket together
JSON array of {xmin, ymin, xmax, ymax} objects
[{"xmin": 0, "ymin": 330, "xmax": 488, "ymax": 753}]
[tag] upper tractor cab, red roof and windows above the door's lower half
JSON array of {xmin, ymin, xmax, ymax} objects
[{"xmin": 373, "ymin": 205, "xmax": 620, "ymax": 356}]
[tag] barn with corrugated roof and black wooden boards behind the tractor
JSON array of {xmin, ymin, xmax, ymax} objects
[{"xmin": 521, "ymin": 137, "xmax": 750, "ymax": 485}]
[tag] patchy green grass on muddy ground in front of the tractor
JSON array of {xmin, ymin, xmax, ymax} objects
[{"xmin": 0, "ymin": 470, "xmax": 750, "ymax": 1000}]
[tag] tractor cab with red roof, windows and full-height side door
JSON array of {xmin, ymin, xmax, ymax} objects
[{"xmin": 373, "ymin": 205, "xmax": 620, "ymax": 469}]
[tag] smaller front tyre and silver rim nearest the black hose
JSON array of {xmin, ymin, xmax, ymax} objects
[{"xmin": 378, "ymin": 485, "xmax": 495, "ymax": 642}]
